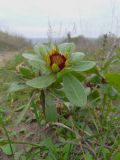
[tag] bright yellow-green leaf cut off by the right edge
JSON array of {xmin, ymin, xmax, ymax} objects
[{"xmin": 106, "ymin": 73, "xmax": 120, "ymax": 91}]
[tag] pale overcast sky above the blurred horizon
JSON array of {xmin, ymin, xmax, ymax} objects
[{"xmin": 0, "ymin": 0, "xmax": 120, "ymax": 38}]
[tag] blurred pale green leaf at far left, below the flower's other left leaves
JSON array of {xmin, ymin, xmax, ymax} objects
[{"xmin": 8, "ymin": 82, "xmax": 28, "ymax": 92}]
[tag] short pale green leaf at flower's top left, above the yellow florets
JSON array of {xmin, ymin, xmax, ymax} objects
[{"xmin": 34, "ymin": 44, "xmax": 48, "ymax": 57}]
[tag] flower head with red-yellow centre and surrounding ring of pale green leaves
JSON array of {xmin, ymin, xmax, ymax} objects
[{"xmin": 23, "ymin": 43, "xmax": 95, "ymax": 106}]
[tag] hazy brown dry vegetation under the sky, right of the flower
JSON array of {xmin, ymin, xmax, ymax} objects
[{"xmin": 67, "ymin": 33, "xmax": 120, "ymax": 54}]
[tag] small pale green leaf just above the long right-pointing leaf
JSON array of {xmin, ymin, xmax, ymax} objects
[{"xmin": 71, "ymin": 52, "xmax": 85, "ymax": 64}]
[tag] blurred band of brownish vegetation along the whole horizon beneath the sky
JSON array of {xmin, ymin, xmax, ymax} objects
[{"xmin": 0, "ymin": 31, "xmax": 120, "ymax": 54}]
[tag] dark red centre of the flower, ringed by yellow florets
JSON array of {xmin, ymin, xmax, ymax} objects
[{"xmin": 50, "ymin": 51, "xmax": 66, "ymax": 70}]
